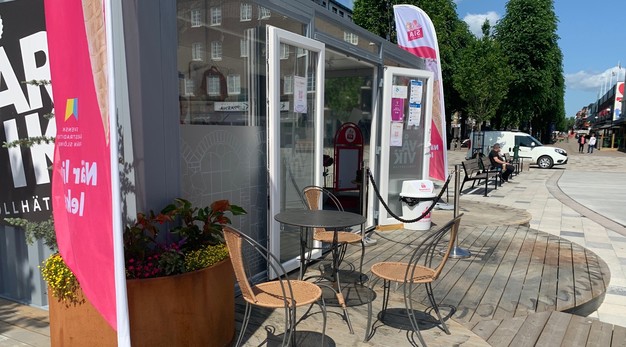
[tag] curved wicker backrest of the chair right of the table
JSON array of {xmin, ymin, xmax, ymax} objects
[{"xmin": 405, "ymin": 214, "xmax": 463, "ymax": 280}]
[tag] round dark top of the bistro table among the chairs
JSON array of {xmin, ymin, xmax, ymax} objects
[{"xmin": 274, "ymin": 210, "xmax": 365, "ymax": 228}]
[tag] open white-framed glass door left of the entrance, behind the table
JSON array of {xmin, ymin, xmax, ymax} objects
[{"xmin": 267, "ymin": 26, "xmax": 324, "ymax": 271}]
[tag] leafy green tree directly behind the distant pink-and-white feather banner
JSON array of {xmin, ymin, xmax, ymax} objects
[{"xmin": 352, "ymin": 0, "xmax": 472, "ymax": 141}]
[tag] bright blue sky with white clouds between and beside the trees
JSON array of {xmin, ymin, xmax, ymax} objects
[{"xmin": 339, "ymin": 0, "xmax": 626, "ymax": 117}]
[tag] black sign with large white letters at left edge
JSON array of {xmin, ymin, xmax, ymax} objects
[{"xmin": 0, "ymin": 0, "xmax": 56, "ymax": 223}]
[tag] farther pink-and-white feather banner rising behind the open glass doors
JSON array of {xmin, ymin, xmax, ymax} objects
[{"xmin": 393, "ymin": 5, "xmax": 448, "ymax": 181}]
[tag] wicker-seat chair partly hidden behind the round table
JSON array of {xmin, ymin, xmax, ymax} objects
[{"xmin": 302, "ymin": 186, "xmax": 365, "ymax": 273}]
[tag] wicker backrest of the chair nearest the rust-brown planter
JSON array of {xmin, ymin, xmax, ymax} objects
[{"xmin": 222, "ymin": 226, "xmax": 293, "ymax": 302}]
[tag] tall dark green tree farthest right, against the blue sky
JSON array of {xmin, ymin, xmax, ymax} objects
[{"xmin": 496, "ymin": 0, "xmax": 565, "ymax": 141}]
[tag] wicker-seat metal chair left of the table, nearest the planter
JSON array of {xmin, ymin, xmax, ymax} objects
[{"xmin": 223, "ymin": 226, "xmax": 326, "ymax": 346}]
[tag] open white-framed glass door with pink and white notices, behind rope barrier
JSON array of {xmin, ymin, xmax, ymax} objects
[{"xmin": 378, "ymin": 67, "xmax": 434, "ymax": 225}]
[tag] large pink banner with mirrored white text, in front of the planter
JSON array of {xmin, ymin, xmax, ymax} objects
[{"xmin": 45, "ymin": 0, "xmax": 117, "ymax": 329}]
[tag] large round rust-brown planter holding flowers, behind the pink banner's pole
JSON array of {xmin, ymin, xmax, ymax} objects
[{"xmin": 49, "ymin": 259, "xmax": 235, "ymax": 347}]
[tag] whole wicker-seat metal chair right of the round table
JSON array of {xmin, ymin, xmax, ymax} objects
[{"xmin": 365, "ymin": 214, "xmax": 462, "ymax": 346}]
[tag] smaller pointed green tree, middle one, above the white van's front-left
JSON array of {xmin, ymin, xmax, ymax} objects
[{"xmin": 453, "ymin": 21, "xmax": 511, "ymax": 127}]
